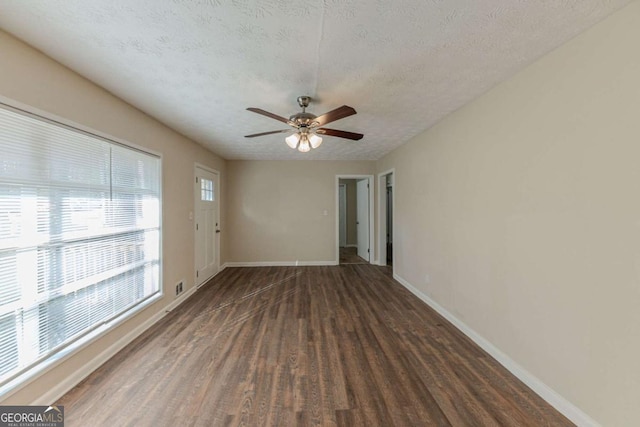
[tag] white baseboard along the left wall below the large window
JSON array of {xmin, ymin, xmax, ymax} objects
[{"xmin": 31, "ymin": 286, "xmax": 197, "ymax": 406}]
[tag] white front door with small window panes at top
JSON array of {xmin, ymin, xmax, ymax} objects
[{"xmin": 194, "ymin": 167, "xmax": 220, "ymax": 286}]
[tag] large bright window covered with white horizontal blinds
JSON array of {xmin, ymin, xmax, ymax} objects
[{"xmin": 0, "ymin": 107, "xmax": 161, "ymax": 392}]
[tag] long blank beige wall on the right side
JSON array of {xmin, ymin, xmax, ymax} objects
[{"xmin": 378, "ymin": 2, "xmax": 640, "ymax": 426}]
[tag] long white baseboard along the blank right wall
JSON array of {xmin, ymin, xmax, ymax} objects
[{"xmin": 393, "ymin": 273, "xmax": 600, "ymax": 427}]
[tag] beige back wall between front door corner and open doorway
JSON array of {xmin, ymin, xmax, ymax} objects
[{"xmin": 226, "ymin": 161, "xmax": 375, "ymax": 263}]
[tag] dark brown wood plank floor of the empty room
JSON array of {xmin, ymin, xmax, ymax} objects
[{"xmin": 57, "ymin": 264, "xmax": 572, "ymax": 427}]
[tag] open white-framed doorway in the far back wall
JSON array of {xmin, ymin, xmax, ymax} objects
[{"xmin": 336, "ymin": 175, "xmax": 374, "ymax": 264}]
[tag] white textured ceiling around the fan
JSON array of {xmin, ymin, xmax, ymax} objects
[{"xmin": 0, "ymin": 0, "xmax": 631, "ymax": 160}]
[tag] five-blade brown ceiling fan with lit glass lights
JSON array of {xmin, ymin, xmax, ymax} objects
[{"xmin": 245, "ymin": 96, "xmax": 364, "ymax": 153}]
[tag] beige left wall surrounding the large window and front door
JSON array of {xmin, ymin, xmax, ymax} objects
[{"xmin": 0, "ymin": 32, "xmax": 226, "ymax": 404}]
